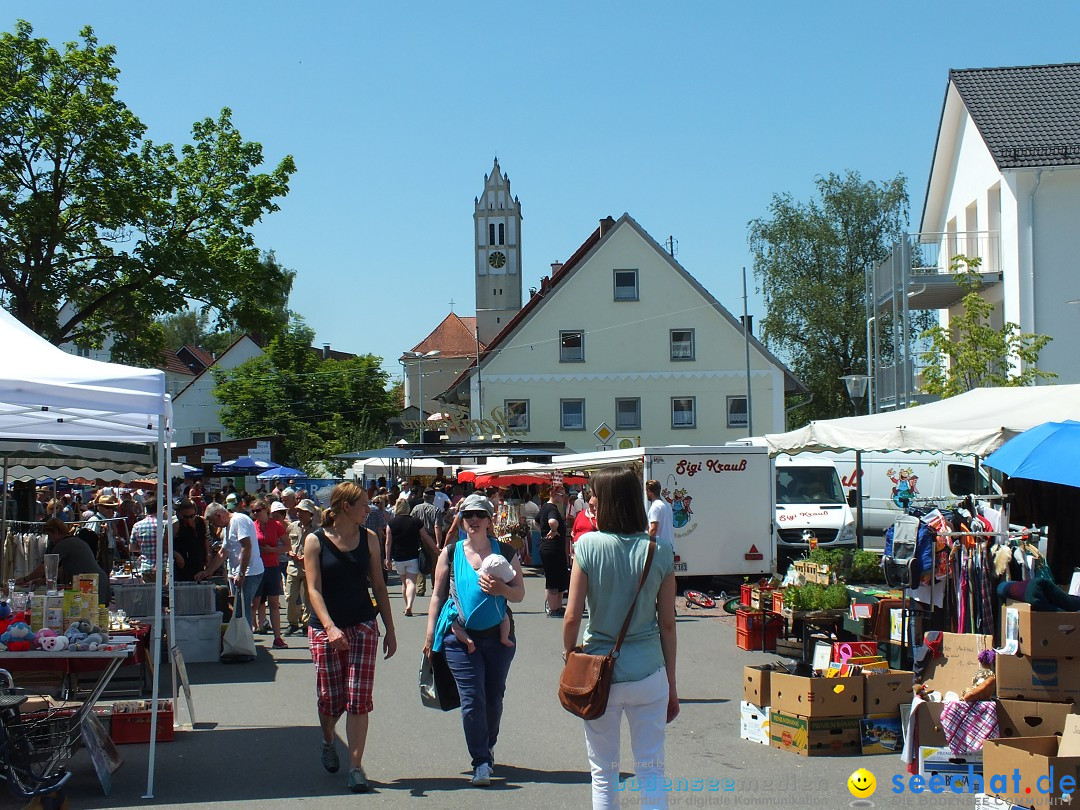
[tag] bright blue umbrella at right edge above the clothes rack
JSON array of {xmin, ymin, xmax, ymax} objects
[{"xmin": 984, "ymin": 419, "xmax": 1080, "ymax": 487}]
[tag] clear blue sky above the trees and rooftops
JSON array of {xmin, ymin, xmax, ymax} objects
[{"xmin": 8, "ymin": 0, "xmax": 1080, "ymax": 380}]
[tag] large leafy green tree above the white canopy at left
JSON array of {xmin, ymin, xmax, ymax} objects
[{"xmin": 0, "ymin": 21, "xmax": 296, "ymax": 363}]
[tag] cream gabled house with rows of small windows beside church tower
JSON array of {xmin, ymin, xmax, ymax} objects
[{"xmin": 442, "ymin": 214, "xmax": 804, "ymax": 451}]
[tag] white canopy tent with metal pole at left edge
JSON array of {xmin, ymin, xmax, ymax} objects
[{"xmin": 0, "ymin": 309, "xmax": 172, "ymax": 798}]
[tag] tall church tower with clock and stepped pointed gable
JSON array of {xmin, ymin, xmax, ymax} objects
[{"xmin": 473, "ymin": 158, "xmax": 522, "ymax": 343}]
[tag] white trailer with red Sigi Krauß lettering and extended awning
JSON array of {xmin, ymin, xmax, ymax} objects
[{"xmin": 552, "ymin": 445, "xmax": 775, "ymax": 577}]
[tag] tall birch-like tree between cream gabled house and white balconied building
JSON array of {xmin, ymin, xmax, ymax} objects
[{"xmin": 748, "ymin": 172, "xmax": 922, "ymax": 423}]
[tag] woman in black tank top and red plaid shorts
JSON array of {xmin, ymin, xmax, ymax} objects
[{"xmin": 303, "ymin": 482, "xmax": 397, "ymax": 793}]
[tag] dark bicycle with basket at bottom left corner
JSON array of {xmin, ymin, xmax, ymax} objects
[{"xmin": 0, "ymin": 670, "xmax": 73, "ymax": 810}]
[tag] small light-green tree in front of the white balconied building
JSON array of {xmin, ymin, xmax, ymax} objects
[{"xmin": 920, "ymin": 255, "xmax": 1057, "ymax": 400}]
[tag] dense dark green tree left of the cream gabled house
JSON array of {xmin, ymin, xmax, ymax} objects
[{"xmin": 214, "ymin": 318, "xmax": 395, "ymax": 474}]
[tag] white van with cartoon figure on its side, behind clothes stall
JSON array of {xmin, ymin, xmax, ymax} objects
[{"xmin": 816, "ymin": 450, "xmax": 1001, "ymax": 549}]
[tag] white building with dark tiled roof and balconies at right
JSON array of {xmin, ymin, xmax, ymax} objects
[{"xmin": 868, "ymin": 64, "xmax": 1080, "ymax": 409}]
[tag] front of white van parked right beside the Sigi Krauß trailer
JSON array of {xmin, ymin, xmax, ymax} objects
[{"xmin": 775, "ymin": 460, "xmax": 855, "ymax": 568}]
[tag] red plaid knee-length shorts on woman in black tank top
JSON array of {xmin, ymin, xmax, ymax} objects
[{"xmin": 308, "ymin": 619, "xmax": 379, "ymax": 717}]
